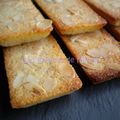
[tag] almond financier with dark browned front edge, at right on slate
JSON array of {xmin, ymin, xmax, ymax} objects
[{"xmin": 61, "ymin": 30, "xmax": 120, "ymax": 84}]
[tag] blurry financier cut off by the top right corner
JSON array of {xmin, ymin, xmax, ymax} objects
[{"xmin": 84, "ymin": 0, "xmax": 120, "ymax": 26}]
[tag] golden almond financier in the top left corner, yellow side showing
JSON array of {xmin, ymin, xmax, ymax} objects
[{"xmin": 0, "ymin": 0, "xmax": 52, "ymax": 46}]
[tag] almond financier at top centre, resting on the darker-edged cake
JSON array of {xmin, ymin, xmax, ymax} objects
[{"xmin": 35, "ymin": 0, "xmax": 106, "ymax": 35}]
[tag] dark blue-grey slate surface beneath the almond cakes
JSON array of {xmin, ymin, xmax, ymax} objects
[{"xmin": 0, "ymin": 0, "xmax": 120, "ymax": 120}]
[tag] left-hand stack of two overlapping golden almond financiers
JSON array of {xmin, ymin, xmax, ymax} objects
[{"xmin": 0, "ymin": 0, "xmax": 82, "ymax": 108}]
